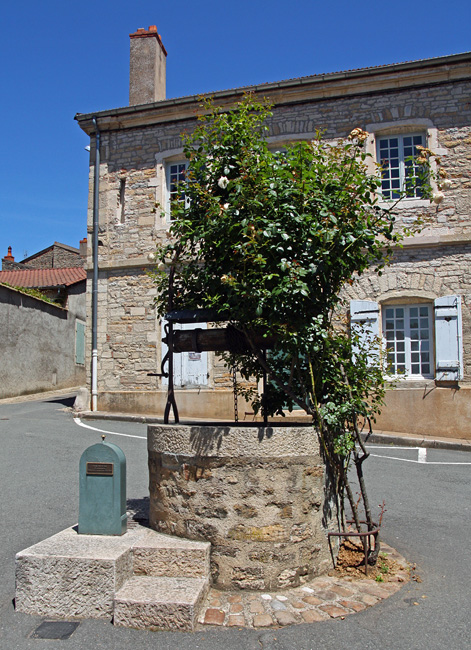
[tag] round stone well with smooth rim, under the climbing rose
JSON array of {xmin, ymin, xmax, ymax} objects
[{"xmin": 148, "ymin": 424, "xmax": 336, "ymax": 590}]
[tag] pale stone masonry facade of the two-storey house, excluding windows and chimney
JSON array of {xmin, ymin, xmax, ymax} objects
[{"xmin": 76, "ymin": 40, "xmax": 471, "ymax": 437}]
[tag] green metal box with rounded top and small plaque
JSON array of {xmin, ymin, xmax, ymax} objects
[{"xmin": 78, "ymin": 441, "xmax": 127, "ymax": 535}]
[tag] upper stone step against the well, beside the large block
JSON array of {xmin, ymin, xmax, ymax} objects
[{"xmin": 132, "ymin": 530, "xmax": 211, "ymax": 578}]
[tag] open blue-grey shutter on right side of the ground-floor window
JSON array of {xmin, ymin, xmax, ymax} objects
[{"xmin": 435, "ymin": 296, "xmax": 463, "ymax": 381}]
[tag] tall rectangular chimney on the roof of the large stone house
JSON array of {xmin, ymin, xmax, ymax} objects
[{"xmin": 129, "ymin": 25, "xmax": 167, "ymax": 106}]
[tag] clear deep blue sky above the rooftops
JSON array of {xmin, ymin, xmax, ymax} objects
[{"xmin": 0, "ymin": 0, "xmax": 471, "ymax": 261}]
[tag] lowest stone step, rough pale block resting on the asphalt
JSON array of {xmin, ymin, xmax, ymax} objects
[{"xmin": 113, "ymin": 576, "xmax": 209, "ymax": 630}]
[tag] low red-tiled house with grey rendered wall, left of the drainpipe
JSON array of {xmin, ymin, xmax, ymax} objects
[{"xmin": 0, "ymin": 244, "xmax": 87, "ymax": 398}]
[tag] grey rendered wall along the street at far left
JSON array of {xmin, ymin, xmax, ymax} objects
[{"xmin": 0, "ymin": 283, "xmax": 85, "ymax": 398}]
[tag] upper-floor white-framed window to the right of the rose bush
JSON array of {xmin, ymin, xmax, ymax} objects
[{"xmin": 377, "ymin": 133, "xmax": 425, "ymax": 199}]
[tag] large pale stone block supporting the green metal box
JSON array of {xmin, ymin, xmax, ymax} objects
[{"xmin": 15, "ymin": 527, "xmax": 146, "ymax": 619}]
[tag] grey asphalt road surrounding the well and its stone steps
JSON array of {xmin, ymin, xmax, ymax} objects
[{"xmin": 0, "ymin": 398, "xmax": 471, "ymax": 650}]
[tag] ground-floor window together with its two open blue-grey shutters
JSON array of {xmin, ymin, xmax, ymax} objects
[{"xmin": 350, "ymin": 296, "xmax": 463, "ymax": 382}]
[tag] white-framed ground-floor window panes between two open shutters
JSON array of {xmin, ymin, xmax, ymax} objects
[{"xmin": 383, "ymin": 304, "xmax": 433, "ymax": 377}]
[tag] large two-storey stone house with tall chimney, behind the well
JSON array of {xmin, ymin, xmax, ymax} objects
[{"xmin": 76, "ymin": 26, "xmax": 471, "ymax": 438}]
